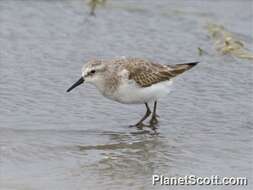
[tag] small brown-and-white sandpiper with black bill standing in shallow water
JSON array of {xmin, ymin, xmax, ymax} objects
[{"xmin": 67, "ymin": 58, "xmax": 198, "ymax": 130}]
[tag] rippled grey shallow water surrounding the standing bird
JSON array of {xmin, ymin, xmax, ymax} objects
[{"xmin": 0, "ymin": 0, "xmax": 253, "ymax": 190}]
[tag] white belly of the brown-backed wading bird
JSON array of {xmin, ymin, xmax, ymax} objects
[{"xmin": 111, "ymin": 80, "xmax": 172, "ymax": 104}]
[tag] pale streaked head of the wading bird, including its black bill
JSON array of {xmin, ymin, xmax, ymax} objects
[{"xmin": 67, "ymin": 60, "xmax": 106, "ymax": 92}]
